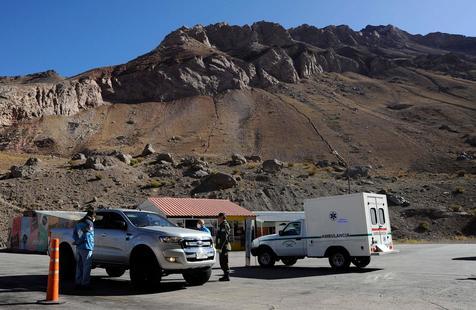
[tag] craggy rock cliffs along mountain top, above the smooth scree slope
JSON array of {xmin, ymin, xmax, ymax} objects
[{"xmin": 0, "ymin": 22, "xmax": 476, "ymax": 126}]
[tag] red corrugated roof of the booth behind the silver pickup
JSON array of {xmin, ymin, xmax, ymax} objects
[{"xmin": 148, "ymin": 197, "xmax": 255, "ymax": 217}]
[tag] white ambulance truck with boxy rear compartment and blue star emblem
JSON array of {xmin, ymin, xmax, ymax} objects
[{"xmin": 251, "ymin": 193, "xmax": 397, "ymax": 269}]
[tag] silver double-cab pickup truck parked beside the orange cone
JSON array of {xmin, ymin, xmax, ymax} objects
[{"xmin": 51, "ymin": 209, "xmax": 215, "ymax": 288}]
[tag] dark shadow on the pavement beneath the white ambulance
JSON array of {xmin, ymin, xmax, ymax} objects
[{"xmin": 231, "ymin": 266, "xmax": 382, "ymax": 280}]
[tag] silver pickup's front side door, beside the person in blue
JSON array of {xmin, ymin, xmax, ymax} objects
[{"xmin": 93, "ymin": 212, "xmax": 129, "ymax": 264}]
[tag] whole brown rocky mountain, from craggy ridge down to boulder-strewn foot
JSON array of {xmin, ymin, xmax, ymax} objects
[{"xmin": 0, "ymin": 22, "xmax": 476, "ymax": 245}]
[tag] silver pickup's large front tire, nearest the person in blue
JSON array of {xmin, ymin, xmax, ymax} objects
[{"xmin": 129, "ymin": 249, "xmax": 162, "ymax": 290}]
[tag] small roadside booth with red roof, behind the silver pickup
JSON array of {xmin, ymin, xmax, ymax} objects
[{"xmin": 137, "ymin": 197, "xmax": 256, "ymax": 250}]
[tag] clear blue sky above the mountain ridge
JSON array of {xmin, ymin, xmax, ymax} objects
[{"xmin": 0, "ymin": 0, "xmax": 476, "ymax": 76}]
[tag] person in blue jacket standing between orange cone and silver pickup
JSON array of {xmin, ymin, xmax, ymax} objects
[{"xmin": 73, "ymin": 210, "xmax": 96, "ymax": 289}]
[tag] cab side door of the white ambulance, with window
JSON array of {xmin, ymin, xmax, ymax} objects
[{"xmin": 273, "ymin": 222, "xmax": 306, "ymax": 257}]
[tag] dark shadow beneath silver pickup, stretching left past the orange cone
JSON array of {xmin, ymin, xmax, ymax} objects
[{"xmin": 0, "ymin": 275, "xmax": 187, "ymax": 306}]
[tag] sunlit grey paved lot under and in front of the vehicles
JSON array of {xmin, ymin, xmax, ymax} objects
[{"xmin": 0, "ymin": 244, "xmax": 476, "ymax": 310}]
